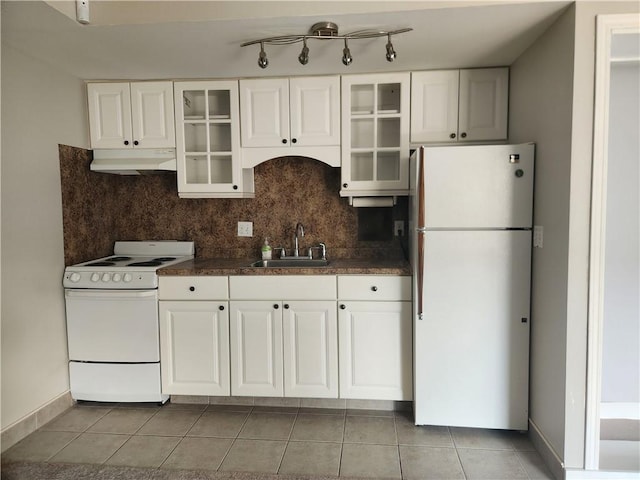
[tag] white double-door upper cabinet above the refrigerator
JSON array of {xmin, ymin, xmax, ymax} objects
[{"xmin": 411, "ymin": 68, "xmax": 509, "ymax": 143}]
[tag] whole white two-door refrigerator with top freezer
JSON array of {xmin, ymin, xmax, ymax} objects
[{"xmin": 410, "ymin": 144, "xmax": 535, "ymax": 430}]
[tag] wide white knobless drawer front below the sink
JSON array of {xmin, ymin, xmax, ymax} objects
[{"xmin": 229, "ymin": 275, "xmax": 336, "ymax": 300}]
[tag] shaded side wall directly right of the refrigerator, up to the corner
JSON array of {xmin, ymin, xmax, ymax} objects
[{"xmin": 509, "ymin": 3, "xmax": 575, "ymax": 464}]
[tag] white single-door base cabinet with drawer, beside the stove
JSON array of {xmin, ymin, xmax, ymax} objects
[{"xmin": 159, "ymin": 276, "xmax": 231, "ymax": 396}]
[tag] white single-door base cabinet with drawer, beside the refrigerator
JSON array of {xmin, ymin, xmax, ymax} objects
[{"xmin": 338, "ymin": 276, "xmax": 413, "ymax": 400}]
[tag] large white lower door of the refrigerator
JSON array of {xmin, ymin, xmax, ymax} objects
[{"xmin": 414, "ymin": 230, "xmax": 531, "ymax": 430}]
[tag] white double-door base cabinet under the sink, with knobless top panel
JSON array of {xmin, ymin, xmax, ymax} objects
[{"xmin": 229, "ymin": 276, "xmax": 338, "ymax": 398}]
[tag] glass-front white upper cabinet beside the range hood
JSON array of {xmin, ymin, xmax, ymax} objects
[{"xmin": 174, "ymin": 81, "xmax": 254, "ymax": 198}]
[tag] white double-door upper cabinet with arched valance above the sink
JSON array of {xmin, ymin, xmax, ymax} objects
[{"xmin": 240, "ymin": 76, "xmax": 340, "ymax": 167}]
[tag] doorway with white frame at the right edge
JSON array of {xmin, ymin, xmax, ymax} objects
[{"xmin": 585, "ymin": 15, "xmax": 640, "ymax": 473}]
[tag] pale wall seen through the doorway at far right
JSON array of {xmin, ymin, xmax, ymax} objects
[{"xmin": 602, "ymin": 60, "xmax": 640, "ymax": 403}]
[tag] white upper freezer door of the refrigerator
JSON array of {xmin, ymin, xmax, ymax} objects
[{"xmin": 422, "ymin": 144, "xmax": 535, "ymax": 229}]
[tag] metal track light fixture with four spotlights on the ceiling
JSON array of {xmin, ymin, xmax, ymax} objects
[{"xmin": 240, "ymin": 22, "xmax": 413, "ymax": 68}]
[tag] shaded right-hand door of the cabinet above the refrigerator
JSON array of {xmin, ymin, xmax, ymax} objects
[{"xmin": 458, "ymin": 68, "xmax": 509, "ymax": 141}]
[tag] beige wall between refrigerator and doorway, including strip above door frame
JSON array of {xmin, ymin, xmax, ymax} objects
[{"xmin": 509, "ymin": 2, "xmax": 639, "ymax": 468}]
